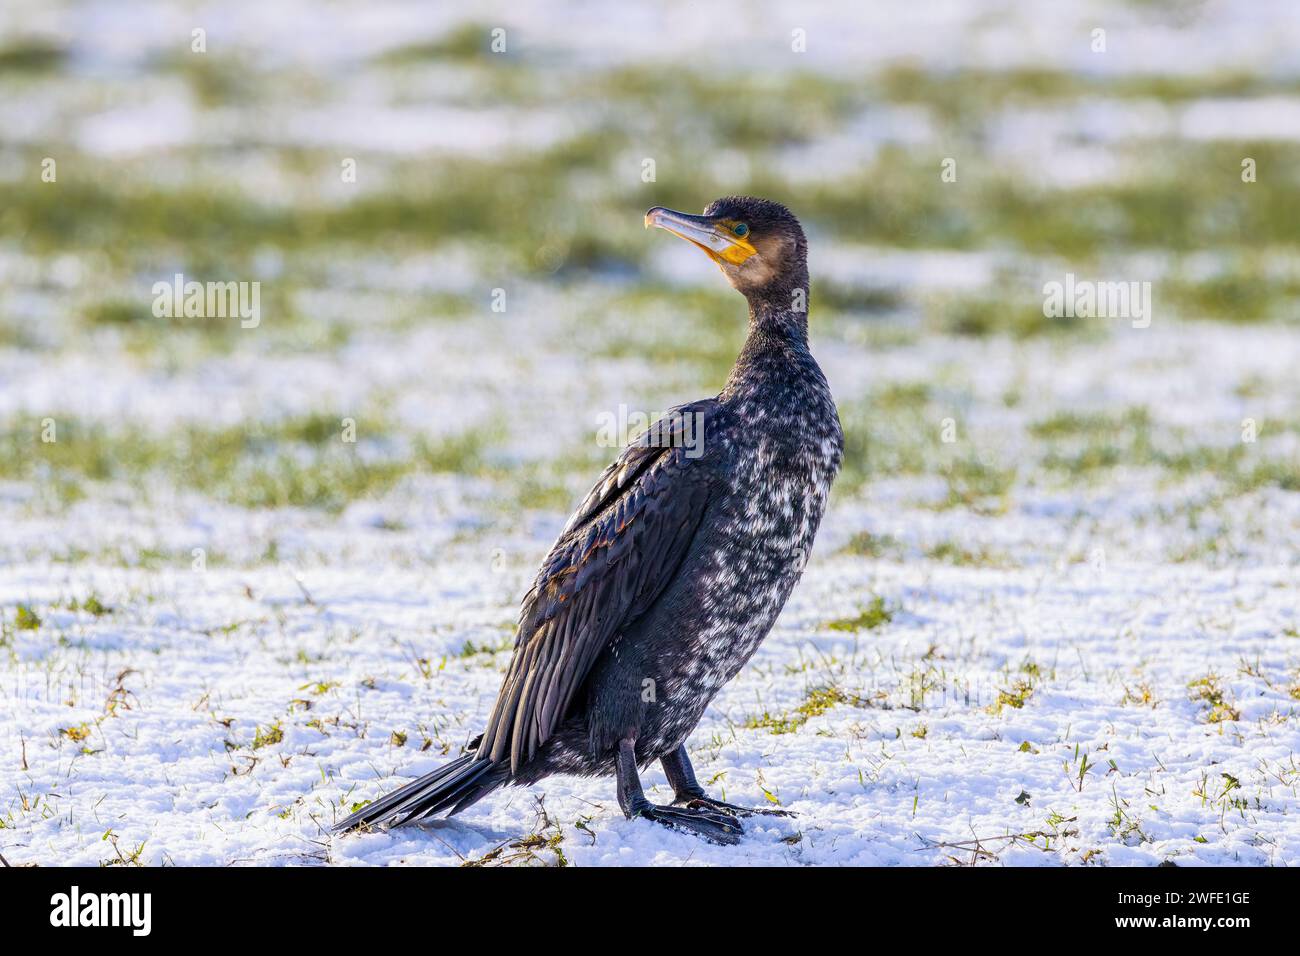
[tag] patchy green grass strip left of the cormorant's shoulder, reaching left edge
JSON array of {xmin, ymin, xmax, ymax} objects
[{"xmin": 0, "ymin": 412, "xmax": 626, "ymax": 520}]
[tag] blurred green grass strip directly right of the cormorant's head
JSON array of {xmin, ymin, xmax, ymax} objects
[{"xmin": 761, "ymin": 143, "xmax": 1300, "ymax": 260}]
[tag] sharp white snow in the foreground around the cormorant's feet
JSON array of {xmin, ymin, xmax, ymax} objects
[{"xmin": 0, "ymin": 555, "xmax": 1300, "ymax": 865}]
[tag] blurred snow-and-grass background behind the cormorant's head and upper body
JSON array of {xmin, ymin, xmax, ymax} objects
[{"xmin": 0, "ymin": 0, "xmax": 1300, "ymax": 561}]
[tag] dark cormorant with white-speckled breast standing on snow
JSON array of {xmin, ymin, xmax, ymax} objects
[{"xmin": 334, "ymin": 196, "xmax": 844, "ymax": 843}]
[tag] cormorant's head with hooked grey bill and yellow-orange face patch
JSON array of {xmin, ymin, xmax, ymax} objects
[{"xmin": 646, "ymin": 196, "xmax": 807, "ymax": 299}]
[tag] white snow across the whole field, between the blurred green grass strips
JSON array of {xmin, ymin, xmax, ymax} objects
[{"xmin": 0, "ymin": 0, "xmax": 1300, "ymax": 866}]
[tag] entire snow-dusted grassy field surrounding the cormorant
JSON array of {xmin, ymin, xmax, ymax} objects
[{"xmin": 0, "ymin": 0, "xmax": 1300, "ymax": 865}]
